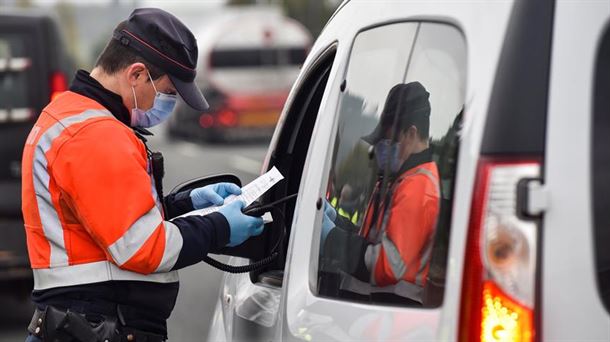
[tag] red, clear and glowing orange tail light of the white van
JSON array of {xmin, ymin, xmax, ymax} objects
[{"xmin": 460, "ymin": 159, "xmax": 540, "ymax": 341}]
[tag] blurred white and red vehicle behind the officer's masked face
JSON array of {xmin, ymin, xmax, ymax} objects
[{"xmin": 168, "ymin": 7, "xmax": 312, "ymax": 141}]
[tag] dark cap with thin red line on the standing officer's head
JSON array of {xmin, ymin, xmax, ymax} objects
[{"xmin": 112, "ymin": 8, "xmax": 209, "ymax": 110}]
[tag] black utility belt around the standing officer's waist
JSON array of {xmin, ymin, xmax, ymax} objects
[{"xmin": 28, "ymin": 305, "xmax": 166, "ymax": 342}]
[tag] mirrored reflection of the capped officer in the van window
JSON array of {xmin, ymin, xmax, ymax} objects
[{"xmin": 322, "ymin": 82, "xmax": 441, "ymax": 303}]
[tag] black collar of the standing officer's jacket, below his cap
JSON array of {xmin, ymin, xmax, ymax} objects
[{"xmin": 70, "ymin": 70, "xmax": 131, "ymax": 127}]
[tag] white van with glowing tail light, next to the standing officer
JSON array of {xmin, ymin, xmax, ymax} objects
[{"xmin": 195, "ymin": 0, "xmax": 610, "ymax": 341}]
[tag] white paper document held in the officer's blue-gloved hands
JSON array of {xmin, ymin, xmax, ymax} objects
[{"xmin": 179, "ymin": 166, "xmax": 284, "ymax": 217}]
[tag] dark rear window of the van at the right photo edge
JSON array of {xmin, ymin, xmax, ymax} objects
[{"xmin": 592, "ymin": 23, "xmax": 610, "ymax": 312}]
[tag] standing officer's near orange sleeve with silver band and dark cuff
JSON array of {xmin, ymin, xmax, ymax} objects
[{"xmin": 49, "ymin": 119, "xmax": 228, "ymax": 274}]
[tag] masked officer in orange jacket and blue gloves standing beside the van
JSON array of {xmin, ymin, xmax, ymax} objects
[{"xmin": 22, "ymin": 8, "xmax": 263, "ymax": 341}]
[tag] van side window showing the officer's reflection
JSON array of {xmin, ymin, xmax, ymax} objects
[{"xmin": 317, "ymin": 22, "xmax": 466, "ymax": 307}]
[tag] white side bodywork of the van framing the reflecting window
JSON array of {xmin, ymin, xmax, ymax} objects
[{"xmin": 270, "ymin": 1, "xmax": 511, "ymax": 340}]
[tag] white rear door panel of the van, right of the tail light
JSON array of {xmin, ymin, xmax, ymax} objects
[{"xmin": 541, "ymin": 1, "xmax": 610, "ymax": 341}]
